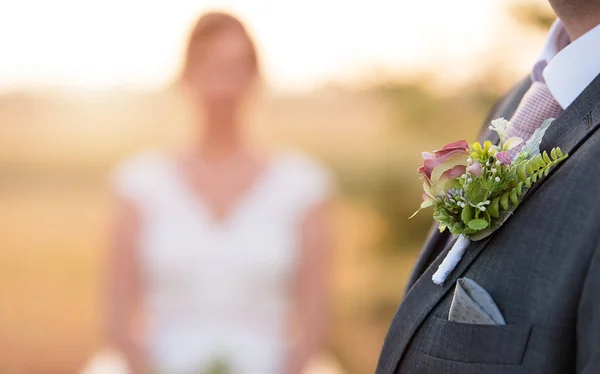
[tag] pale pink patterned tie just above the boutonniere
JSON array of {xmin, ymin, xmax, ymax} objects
[{"xmin": 507, "ymin": 82, "xmax": 563, "ymax": 149}]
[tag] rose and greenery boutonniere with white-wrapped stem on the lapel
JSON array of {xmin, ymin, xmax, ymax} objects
[{"xmin": 411, "ymin": 118, "xmax": 568, "ymax": 284}]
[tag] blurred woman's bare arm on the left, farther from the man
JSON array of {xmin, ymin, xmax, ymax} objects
[{"xmin": 107, "ymin": 197, "xmax": 148, "ymax": 374}]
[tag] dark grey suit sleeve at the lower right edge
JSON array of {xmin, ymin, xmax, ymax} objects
[{"xmin": 577, "ymin": 241, "xmax": 600, "ymax": 374}]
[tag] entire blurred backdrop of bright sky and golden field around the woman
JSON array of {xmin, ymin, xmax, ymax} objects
[{"xmin": 0, "ymin": 0, "xmax": 553, "ymax": 374}]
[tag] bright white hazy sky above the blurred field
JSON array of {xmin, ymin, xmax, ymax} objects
[{"xmin": 0, "ymin": 0, "xmax": 536, "ymax": 91}]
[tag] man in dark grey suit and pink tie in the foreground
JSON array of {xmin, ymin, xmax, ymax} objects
[{"xmin": 376, "ymin": 0, "xmax": 600, "ymax": 374}]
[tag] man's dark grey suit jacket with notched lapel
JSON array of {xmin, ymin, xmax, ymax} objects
[{"xmin": 376, "ymin": 76, "xmax": 600, "ymax": 374}]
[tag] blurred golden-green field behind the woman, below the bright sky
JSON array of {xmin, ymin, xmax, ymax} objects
[{"xmin": 0, "ymin": 84, "xmax": 493, "ymax": 374}]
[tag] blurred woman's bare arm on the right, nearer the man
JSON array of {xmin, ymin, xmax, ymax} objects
[{"xmin": 284, "ymin": 201, "xmax": 331, "ymax": 374}]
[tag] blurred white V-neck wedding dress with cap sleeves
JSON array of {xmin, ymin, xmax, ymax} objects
[{"xmin": 112, "ymin": 152, "xmax": 330, "ymax": 374}]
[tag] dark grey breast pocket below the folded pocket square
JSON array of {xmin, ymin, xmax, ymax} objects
[{"xmin": 419, "ymin": 317, "xmax": 531, "ymax": 365}]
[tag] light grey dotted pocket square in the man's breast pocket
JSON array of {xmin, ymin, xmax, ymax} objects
[{"xmin": 448, "ymin": 278, "xmax": 506, "ymax": 325}]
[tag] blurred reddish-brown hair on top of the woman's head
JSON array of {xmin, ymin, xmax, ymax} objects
[{"xmin": 181, "ymin": 11, "xmax": 259, "ymax": 78}]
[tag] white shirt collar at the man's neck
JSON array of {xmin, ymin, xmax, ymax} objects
[{"xmin": 532, "ymin": 19, "xmax": 600, "ymax": 109}]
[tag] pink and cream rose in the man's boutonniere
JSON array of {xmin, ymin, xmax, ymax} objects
[{"xmin": 417, "ymin": 140, "xmax": 469, "ymax": 208}]
